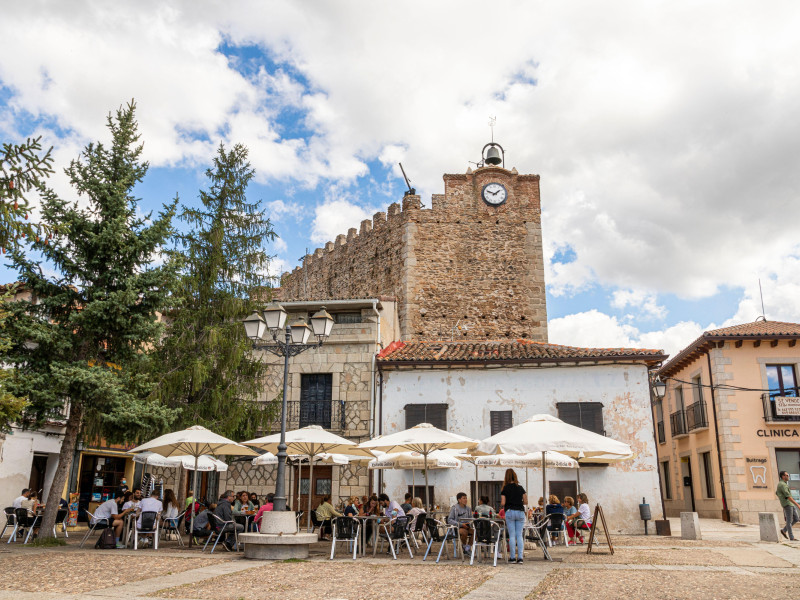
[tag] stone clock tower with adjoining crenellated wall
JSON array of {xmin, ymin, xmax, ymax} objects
[{"xmin": 280, "ymin": 158, "xmax": 547, "ymax": 342}]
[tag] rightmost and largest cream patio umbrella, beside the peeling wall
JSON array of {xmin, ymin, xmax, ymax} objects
[{"xmin": 478, "ymin": 415, "xmax": 633, "ymax": 508}]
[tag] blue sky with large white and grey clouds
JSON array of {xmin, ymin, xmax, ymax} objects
[{"xmin": 0, "ymin": 0, "xmax": 800, "ymax": 352}]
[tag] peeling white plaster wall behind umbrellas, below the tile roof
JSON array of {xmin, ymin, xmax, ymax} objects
[{"xmin": 383, "ymin": 365, "xmax": 661, "ymax": 533}]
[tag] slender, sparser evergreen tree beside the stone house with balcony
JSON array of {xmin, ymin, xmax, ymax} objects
[{"xmin": 153, "ymin": 144, "xmax": 276, "ymax": 446}]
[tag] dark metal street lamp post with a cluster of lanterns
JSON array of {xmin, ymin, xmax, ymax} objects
[{"xmin": 244, "ymin": 304, "xmax": 333, "ymax": 511}]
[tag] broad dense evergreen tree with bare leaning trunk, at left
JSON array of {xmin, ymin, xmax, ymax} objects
[{"xmin": 4, "ymin": 103, "xmax": 178, "ymax": 536}]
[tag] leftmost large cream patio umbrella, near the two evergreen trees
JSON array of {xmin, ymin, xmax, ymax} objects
[{"xmin": 128, "ymin": 425, "xmax": 257, "ymax": 547}]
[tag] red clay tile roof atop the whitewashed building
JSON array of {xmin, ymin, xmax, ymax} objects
[{"xmin": 378, "ymin": 340, "xmax": 667, "ymax": 366}]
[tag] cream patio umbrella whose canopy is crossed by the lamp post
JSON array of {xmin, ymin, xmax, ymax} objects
[{"xmin": 242, "ymin": 425, "xmax": 372, "ymax": 530}]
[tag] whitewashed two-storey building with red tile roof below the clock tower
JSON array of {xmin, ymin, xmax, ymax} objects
[{"xmin": 376, "ymin": 340, "xmax": 666, "ymax": 533}]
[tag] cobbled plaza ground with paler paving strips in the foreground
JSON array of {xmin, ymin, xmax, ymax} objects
[{"xmin": 0, "ymin": 519, "xmax": 800, "ymax": 600}]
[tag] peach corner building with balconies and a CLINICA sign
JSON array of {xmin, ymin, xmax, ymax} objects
[{"xmin": 653, "ymin": 320, "xmax": 800, "ymax": 523}]
